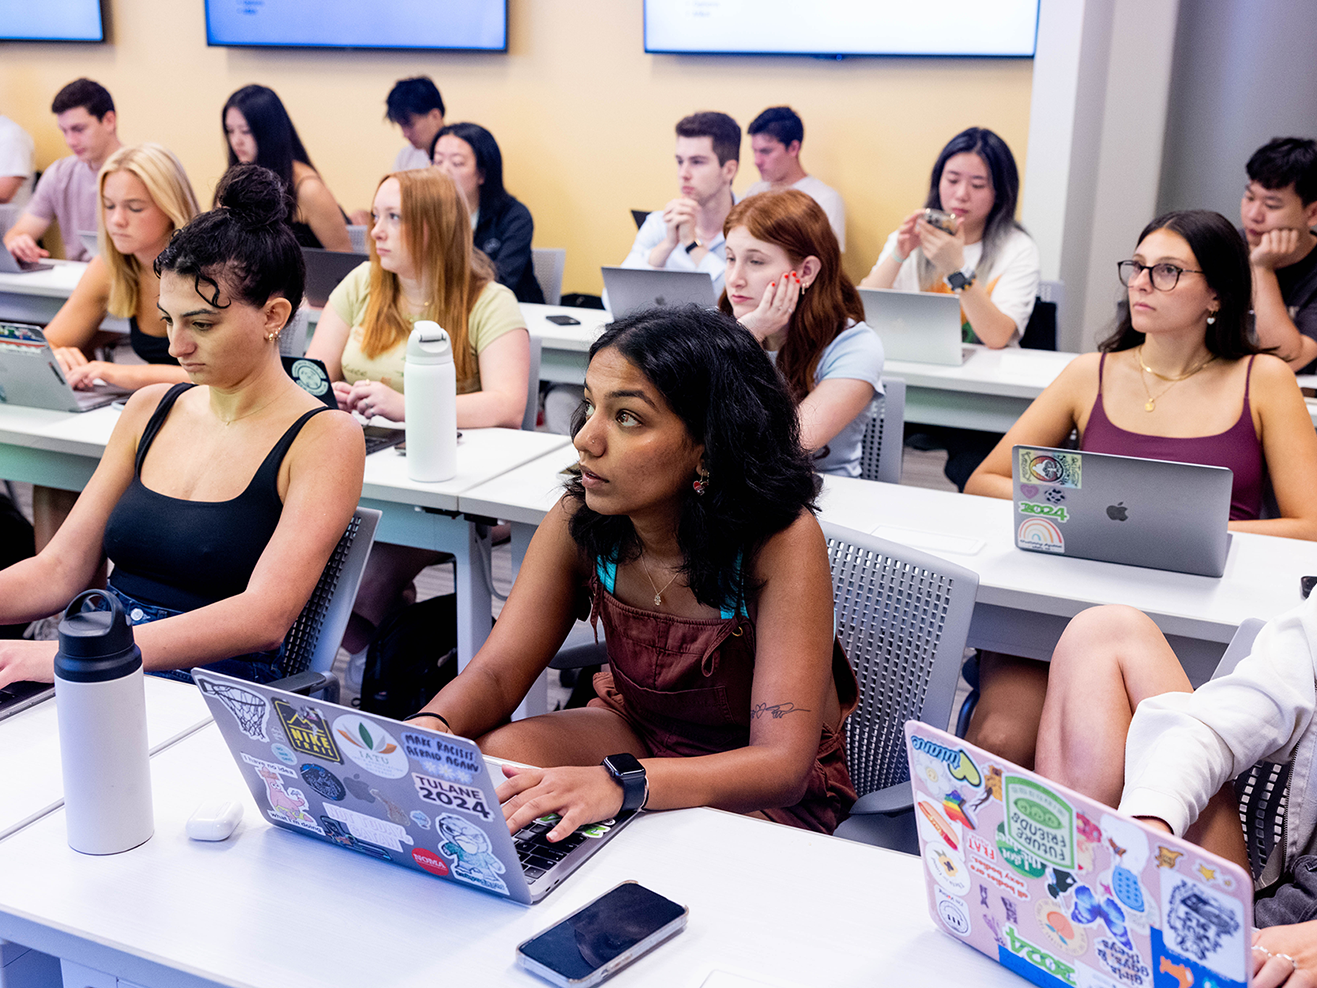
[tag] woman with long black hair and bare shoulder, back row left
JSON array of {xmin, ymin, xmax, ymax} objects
[{"xmin": 220, "ymin": 86, "xmax": 352, "ymax": 250}]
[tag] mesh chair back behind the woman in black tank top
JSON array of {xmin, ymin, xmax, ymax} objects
[{"xmin": 283, "ymin": 507, "xmax": 379, "ymax": 676}]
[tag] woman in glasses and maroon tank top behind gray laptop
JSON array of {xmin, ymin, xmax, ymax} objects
[{"xmin": 965, "ymin": 209, "xmax": 1317, "ymax": 764}]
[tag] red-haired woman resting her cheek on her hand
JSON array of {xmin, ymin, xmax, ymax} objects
[{"xmin": 718, "ymin": 188, "xmax": 882, "ymax": 477}]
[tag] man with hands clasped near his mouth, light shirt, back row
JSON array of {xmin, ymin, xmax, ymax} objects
[{"xmin": 622, "ymin": 111, "xmax": 740, "ymax": 291}]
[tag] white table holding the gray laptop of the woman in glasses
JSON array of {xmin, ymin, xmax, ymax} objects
[{"xmin": 461, "ymin": 449, "xmax": 1317, "ymax": 685}]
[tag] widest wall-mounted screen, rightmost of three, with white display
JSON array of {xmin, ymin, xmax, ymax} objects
[{"xmin": 645, "ymin": 0, "xmax": 1039, "ymax": 58}]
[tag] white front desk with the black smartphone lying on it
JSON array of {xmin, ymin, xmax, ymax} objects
[{"xmin": 0, "ymin": 726, "xmax": 1022, "ymax": 988}]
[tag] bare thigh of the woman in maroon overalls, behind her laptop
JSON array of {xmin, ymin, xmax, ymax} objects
[{"xmin": 475, "ymin": 706, "xmax": 649, "ymax": 768}]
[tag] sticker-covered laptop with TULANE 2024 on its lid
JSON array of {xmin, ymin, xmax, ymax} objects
[{"xmin": 192, "ymin": 669, "xmax": 636, "ymax": 905}]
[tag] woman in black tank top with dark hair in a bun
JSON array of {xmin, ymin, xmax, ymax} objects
[{"xmin": 0, "ymin": 166, "xmax": 365, "ymax": 688}]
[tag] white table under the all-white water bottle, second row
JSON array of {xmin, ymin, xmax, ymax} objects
[{"xmin": 0, "ymin": 406, "xmax": 570, "ymax": 665}]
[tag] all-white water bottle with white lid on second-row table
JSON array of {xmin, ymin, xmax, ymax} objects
[{"xmin": 403, "ymin": 319, "xmax": 457, "ymax": 482}]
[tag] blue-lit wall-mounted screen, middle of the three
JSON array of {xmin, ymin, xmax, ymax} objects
[{"xmin": 205, "ymin": 0, "xmax": 507, "ymax": 51}]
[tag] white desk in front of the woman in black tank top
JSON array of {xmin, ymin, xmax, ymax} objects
[{"xmin": 0, "ymin": 676, "xmax": 211, "ymax": 840}]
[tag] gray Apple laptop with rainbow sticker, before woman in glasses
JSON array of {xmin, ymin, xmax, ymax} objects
[{"xmin": 1010, "ymin": 447, "xmax": 1234, "ymax": 577}]
